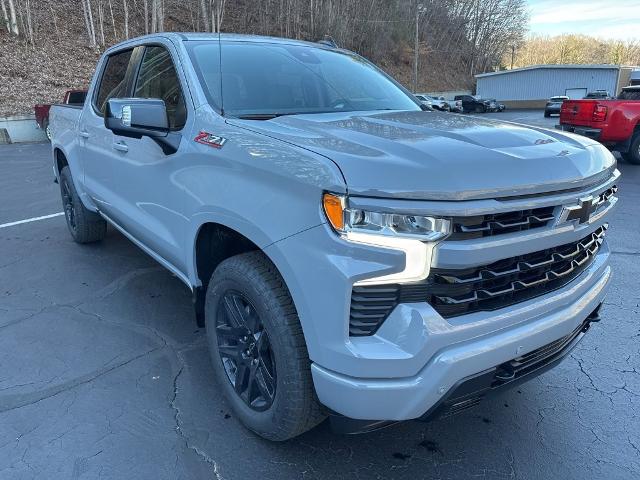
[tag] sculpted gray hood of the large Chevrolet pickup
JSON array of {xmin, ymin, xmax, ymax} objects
[{"xmin": 229, "ymin": 111, "xmax": 615, "ymax": 200}]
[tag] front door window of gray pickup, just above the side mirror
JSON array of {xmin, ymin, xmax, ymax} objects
[{"xmin": 134, "ymin": 47, "xmax": 187, "ymax": 130}]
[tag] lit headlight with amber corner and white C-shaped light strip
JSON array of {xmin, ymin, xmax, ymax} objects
[{"xmin": 323, "ymin": 193, "xmax": 451, "ymax": 285}]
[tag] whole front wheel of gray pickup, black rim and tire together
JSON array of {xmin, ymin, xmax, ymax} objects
[{"xmin": 205, "ymin": 252, "xmax": 326, "ymax": 441}]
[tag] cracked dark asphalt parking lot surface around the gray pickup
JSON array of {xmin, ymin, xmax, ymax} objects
[{"xmin": 0, "ymin": 112, "xmax": 640, "ymax": 480}]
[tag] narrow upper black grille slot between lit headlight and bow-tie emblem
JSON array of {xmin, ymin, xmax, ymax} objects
[{"xmin": 447, "ymin": 207, "xmax": 555, "ymax": 240}]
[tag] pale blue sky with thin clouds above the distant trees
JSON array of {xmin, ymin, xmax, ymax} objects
[{"xmin": 527, "ymin": 0, "xmax": 640, "ymax": 40}]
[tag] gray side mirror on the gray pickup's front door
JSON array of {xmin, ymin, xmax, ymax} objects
[{"xmin": 104, "ymin": 98, "xmax": 182, "ymax": 155}]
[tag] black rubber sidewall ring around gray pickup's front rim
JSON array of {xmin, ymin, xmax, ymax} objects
[{"xmin": 205, "ymin": 265, "xmax": 292, "ymax": 436}]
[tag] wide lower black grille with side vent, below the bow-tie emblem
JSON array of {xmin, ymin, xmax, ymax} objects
[{"xmin": 349, "ymin": 225, "xmax": 607, "ymax": 336}]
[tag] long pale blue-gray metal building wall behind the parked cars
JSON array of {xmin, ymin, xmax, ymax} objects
[{"xmin": 476, "ymin": 67, "xmax": 618, "ymax": 101}]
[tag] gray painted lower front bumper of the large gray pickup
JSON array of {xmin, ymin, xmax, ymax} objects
[{"xmin": 311, "ymin": 251, "xmax": 611, "ymax": 421}]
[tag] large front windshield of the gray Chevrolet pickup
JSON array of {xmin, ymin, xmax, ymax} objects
[{"xmin": 188, "ymin": 42, "xmax": 420, "ymax": 119}]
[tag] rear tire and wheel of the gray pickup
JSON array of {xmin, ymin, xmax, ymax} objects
[{"xmin": 60, "ymin": 166, "xmax": 107, "ymax": 243}]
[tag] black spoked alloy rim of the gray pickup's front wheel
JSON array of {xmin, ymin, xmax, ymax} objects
[{"xmin": 216, "ymin": 290, "xmax": 277, "ymax": 412}]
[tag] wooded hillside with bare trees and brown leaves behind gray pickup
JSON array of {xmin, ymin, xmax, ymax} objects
[{"xmin": 0, "ymin": 0, "xmax": 528, "ymax": 116}]
